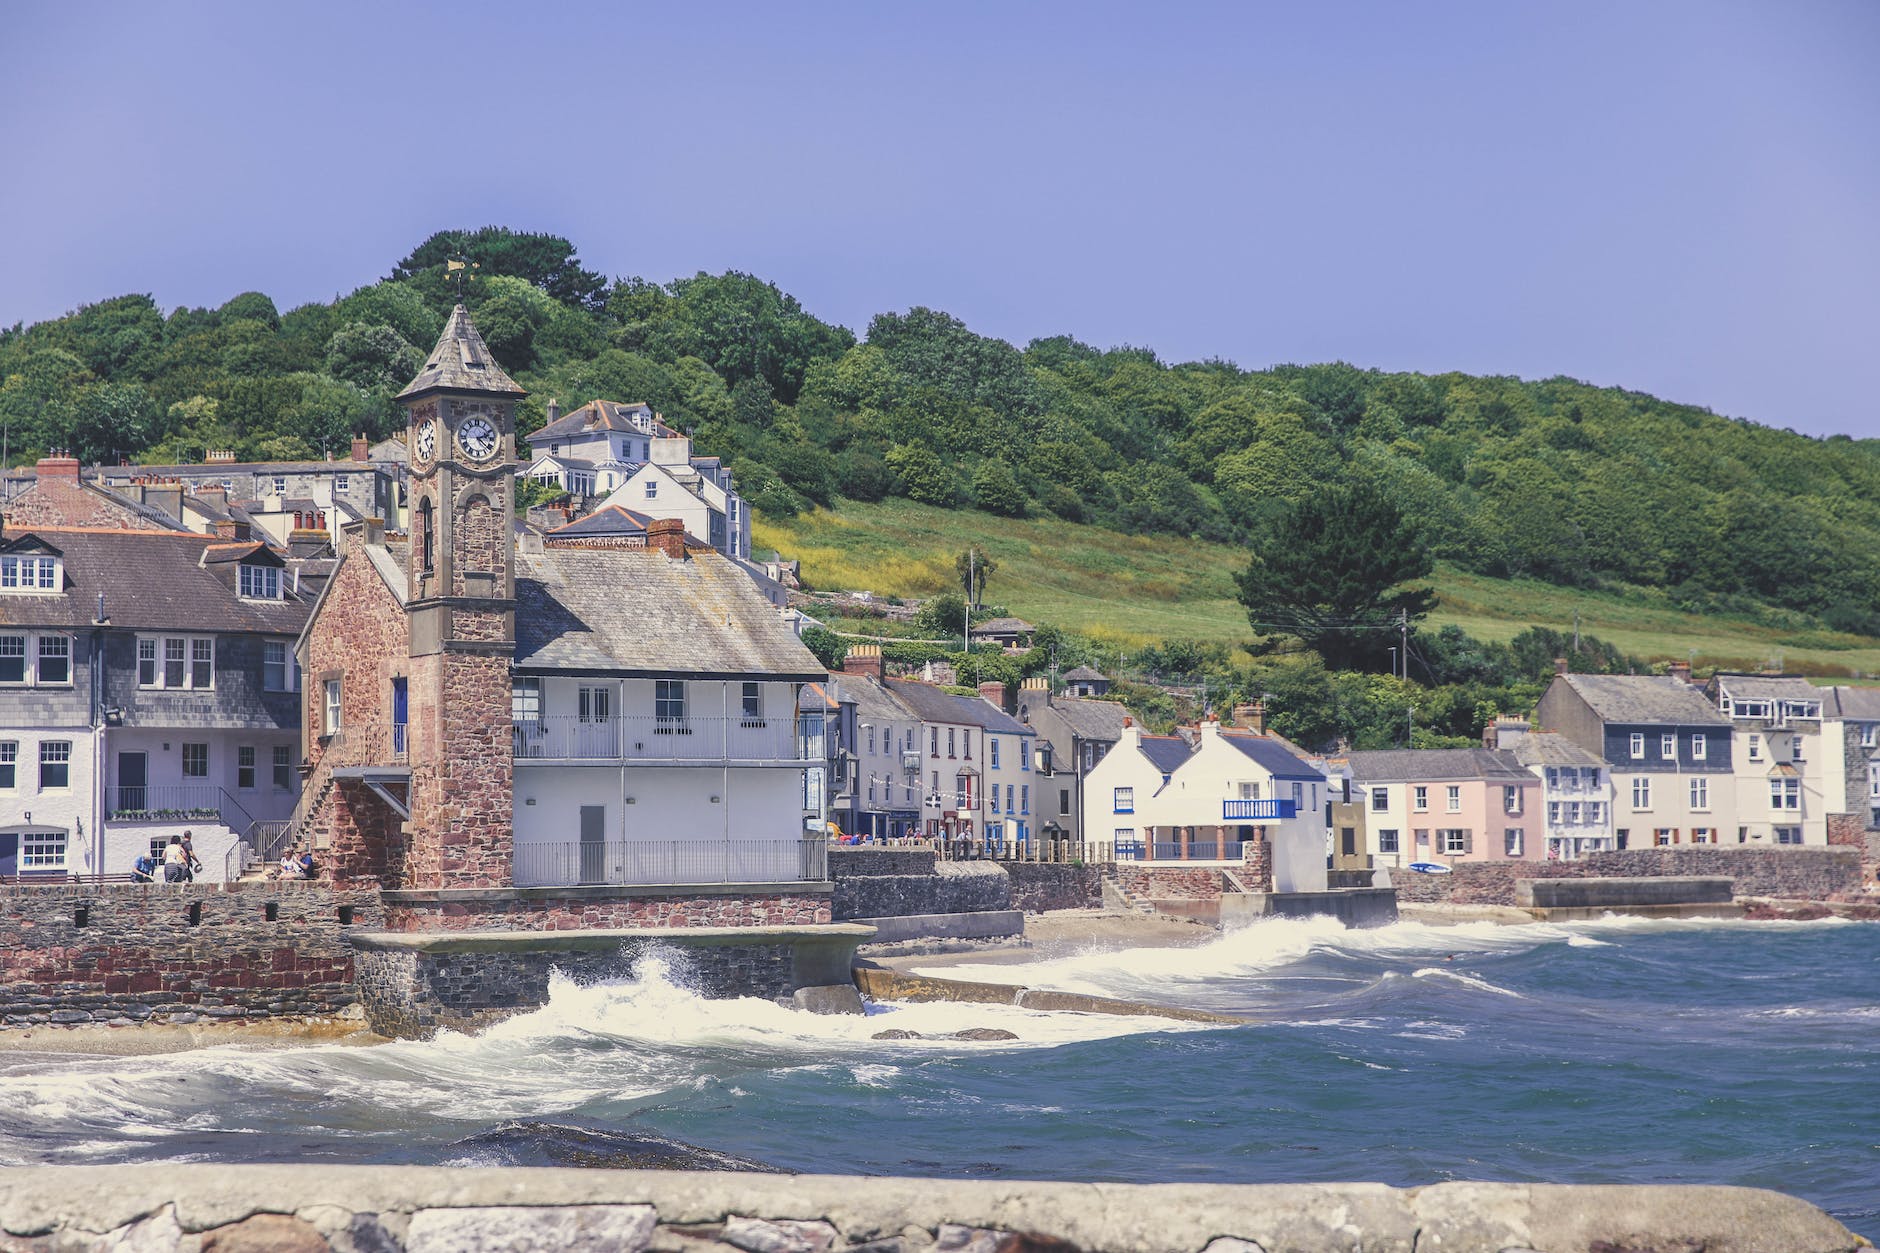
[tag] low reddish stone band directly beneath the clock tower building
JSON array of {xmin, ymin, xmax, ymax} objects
[{"xmin": 385, "ymin": 890, "xmax": 831, "ymax": 931}]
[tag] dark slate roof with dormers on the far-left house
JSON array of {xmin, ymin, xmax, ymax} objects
[{"xmin": 0, "ymin": 527, "xmax": 314, "ymax": 636}]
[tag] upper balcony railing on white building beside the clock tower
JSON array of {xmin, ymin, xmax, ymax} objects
[{"xmin": 513, "ymin": 715, "xmax": 804, "ymax": 766}]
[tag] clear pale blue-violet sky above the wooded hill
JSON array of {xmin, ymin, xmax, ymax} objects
[{"xmin": 0, "ymin": 0, "xmax": 1880, "ymax": 436}]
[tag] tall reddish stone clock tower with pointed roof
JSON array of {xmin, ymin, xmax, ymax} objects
[{"xmin": 393, "ymin": 305, "xmax": 525, "ymax": 888}]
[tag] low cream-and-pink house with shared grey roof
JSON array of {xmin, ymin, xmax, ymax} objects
[{"xmin": 1348, "ymin": 749, "xmax": 1547, "ymax": 867}]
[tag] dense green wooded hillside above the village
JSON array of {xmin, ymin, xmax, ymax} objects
[{"xmin": 11, "ymin": 228, "xmax": 1880, "ymax": 634}]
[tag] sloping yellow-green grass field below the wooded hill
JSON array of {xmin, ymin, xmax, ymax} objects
[{"xmin": 752, "ymin": 500, "xmax": 1880, "ymax": 675}]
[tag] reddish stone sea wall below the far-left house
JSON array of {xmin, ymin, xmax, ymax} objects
[{"xmin": 0, "ymin": 882, "xmax": 384, "ymax": 1027}]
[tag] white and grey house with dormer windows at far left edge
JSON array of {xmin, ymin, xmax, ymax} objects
[{"xmin": 0, "ymin": 527, "xmax": 325, "ymax": 879}]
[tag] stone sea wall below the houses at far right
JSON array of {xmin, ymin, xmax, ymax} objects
[{"xmin": 1391, "ymin": 847, "xmax": 1861, "ymax": 905}]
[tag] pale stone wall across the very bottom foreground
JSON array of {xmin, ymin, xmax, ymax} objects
[{"xmin": 0, "ymin": 1163, "xmax": 1863, "ymax": 1253}]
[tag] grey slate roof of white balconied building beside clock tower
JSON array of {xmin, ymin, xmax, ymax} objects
[{"xmin": 515, "ymin": 547, "xmax": 827, "ymax": 683}]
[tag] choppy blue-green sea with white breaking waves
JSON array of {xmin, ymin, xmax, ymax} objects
[{"xmin": 0, "ymin": 918, "xmax": 1880, "ymax": 1232}]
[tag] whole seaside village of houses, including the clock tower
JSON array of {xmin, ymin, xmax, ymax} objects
[{"xmin": 0, "ymin": 307, "xmax": 1880, "ymax": 892}]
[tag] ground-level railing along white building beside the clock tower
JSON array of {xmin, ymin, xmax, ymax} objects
[{"xmin": 513, "ymin": 837, "xmax": 829, "ymax": 888}]
